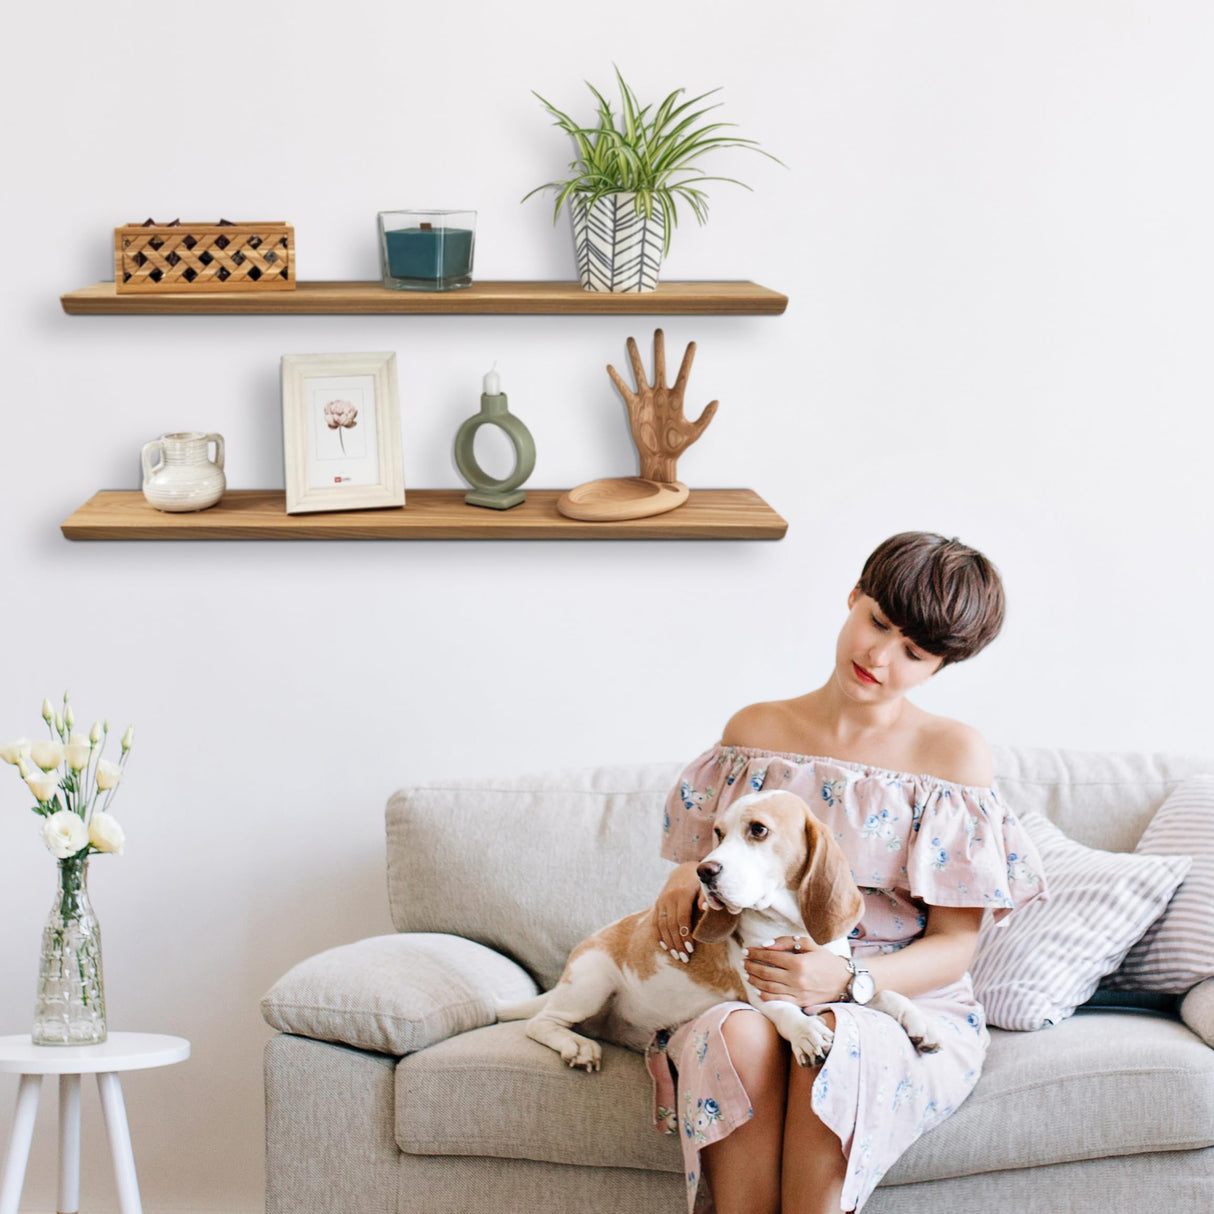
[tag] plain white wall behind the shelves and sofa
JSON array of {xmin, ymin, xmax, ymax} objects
[{"xmin": 0, "ymin": 0, "xmax": 1214, "ymax": 1210}]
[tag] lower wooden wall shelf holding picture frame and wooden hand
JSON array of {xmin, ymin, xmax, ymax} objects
[{"xmin": 61, "ymin": 489, "xmax": 788, "ymax": 539}]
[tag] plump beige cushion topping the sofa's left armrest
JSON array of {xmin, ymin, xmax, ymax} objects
[{"xmin": 261, "ymin": 932, "xmax": 535, "ymax": 1055}]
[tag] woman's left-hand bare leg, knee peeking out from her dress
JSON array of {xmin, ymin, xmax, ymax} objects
[{"xmin": 702, "ymin": 1009, "xmax": 786, "ymax": 1214}]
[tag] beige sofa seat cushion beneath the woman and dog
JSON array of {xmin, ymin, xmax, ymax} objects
[{"xmin": 396, "ymin": 1012, "xmax": 1214, "ymax": 1184}]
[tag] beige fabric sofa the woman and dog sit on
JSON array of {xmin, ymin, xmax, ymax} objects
[{"xmin": 262, "ymin": 749, "xmax": 1214, "ymax": 1214}]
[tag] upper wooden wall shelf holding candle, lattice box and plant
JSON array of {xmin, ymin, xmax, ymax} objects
[{"xmin": 59, "ymin": 282, "xmax": 788, "ymax": 316}]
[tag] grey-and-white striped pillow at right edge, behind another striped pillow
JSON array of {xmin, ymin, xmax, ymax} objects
[{"xmin": 1101, "ymin": 776, "xmax": 1214, "ymax": 994}]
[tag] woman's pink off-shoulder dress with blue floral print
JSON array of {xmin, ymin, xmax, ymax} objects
[{"xmin": 646, "ymin": 745, "xmax": 1044, "ymax": 1214}]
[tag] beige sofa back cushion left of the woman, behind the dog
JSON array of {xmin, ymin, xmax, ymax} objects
[{"xmin": 387, "ymin": 764, "xmax": 677, "ymax": 988}]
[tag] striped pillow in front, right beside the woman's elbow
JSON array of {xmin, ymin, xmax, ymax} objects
[{"xmin": 970, "ymin": 813, "xmax": 1190, "ymax": 1029}]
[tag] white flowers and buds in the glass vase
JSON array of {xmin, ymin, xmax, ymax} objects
[{"xmin": 0, "ymin": 692, "xmax": 135, "ymax": 860}]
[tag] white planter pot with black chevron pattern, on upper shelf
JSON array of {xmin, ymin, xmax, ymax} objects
[{"xmin": 571, "ymin": 192, "xmax": 663, "ymax": 294}]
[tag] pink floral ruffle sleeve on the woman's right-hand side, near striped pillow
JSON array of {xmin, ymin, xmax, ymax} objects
[{"xmin": 900, "ymin": 781, "xmax": 1045, "ymax": 920}]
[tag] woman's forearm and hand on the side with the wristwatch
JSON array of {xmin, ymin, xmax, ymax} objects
[{"xmin": 745, "ymin": 906, "xmax": 982, "ymax": 1008}]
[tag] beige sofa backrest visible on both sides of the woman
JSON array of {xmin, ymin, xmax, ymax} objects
[{"xmin": 387, "ymin": 747, "xmax": 1214, "ymax": 988}]
